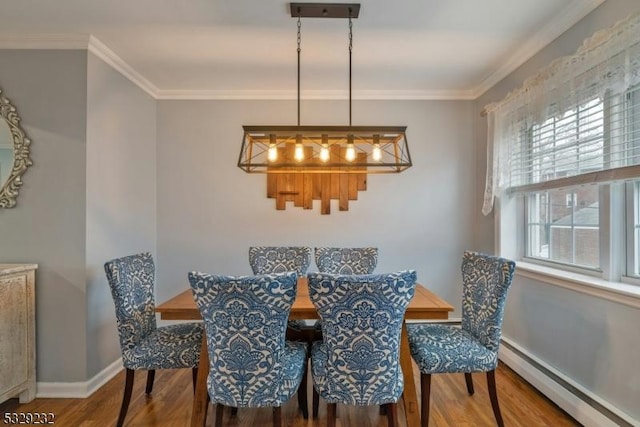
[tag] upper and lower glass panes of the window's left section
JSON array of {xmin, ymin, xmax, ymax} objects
[{"xmin": 514, "ymin": 99, "xmax": 605, "ymax": 269}]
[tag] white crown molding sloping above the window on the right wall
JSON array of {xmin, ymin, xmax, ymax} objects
[{"xmin": 473, "ymin": 0, "xmax": 606, "ymax": 99}]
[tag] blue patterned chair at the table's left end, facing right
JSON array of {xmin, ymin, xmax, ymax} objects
[{"xmin": 104, "ymin": 252, "xmax": 203, "ymax": 426}]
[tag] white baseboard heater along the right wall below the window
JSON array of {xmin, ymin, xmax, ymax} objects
[{"xmin": 500, "ymin": 337, "xmax": 640, "ymax": 427}]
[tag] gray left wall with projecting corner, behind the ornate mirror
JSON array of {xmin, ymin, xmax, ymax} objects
[{"xmin": 0, "ymin": 50, "xmax": 156, "ymax": 382}]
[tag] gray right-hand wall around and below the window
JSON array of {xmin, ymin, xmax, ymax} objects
[{"xmin": 473, "ymin": 0, "xmax": 640, "ymax": 420}]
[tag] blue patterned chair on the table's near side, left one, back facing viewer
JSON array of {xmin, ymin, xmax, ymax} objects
[{"xmin": 189, "ymin": 272, "xmax": 307, "ymax": 426}]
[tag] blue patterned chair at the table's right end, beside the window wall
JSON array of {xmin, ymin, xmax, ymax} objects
[{"xmin": 407, "ymin": 252, "xmax": 515, "ymax": 427}]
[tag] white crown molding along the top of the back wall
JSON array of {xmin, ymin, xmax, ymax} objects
[{"xmin": 156, "ymin": 89, "xmax": 475, "ymax": 101}]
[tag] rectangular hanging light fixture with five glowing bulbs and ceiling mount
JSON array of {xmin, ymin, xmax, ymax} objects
[{"xmin": 238, "ymin": 3, "xmax": 411, "ymax": 173}]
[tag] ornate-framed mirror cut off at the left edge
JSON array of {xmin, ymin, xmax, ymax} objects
[{"xmin": 0, "ymin": 90, "xmax": 33, "ymax": 208}]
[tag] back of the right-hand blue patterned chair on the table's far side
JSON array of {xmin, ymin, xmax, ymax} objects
[{"xmin": 315, "ymin": 248, "xmax": 378, "ymax": 274}]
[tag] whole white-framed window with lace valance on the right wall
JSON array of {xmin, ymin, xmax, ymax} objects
[{"xmin": 482, "ymin": 14, "xmax": 640, "ymax": 292}]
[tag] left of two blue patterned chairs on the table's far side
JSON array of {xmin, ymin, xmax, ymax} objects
[{"xmin": 249, "ymin": 246, "xmax": 313, "ymax": 341}]
